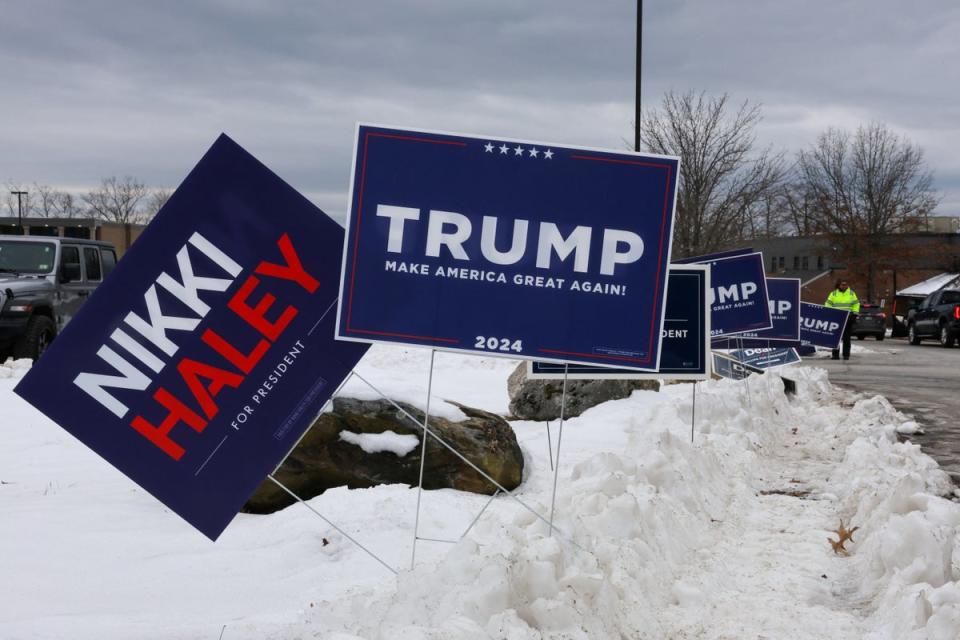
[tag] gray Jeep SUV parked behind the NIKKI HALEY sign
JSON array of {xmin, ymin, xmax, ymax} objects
[{"xmin": 0, "ymin": 236, "xmax": 117, "ymax": 360}]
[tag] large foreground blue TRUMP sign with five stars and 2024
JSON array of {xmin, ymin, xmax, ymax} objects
[{"xmin": 337, "ymin": 125, "xmax": 678, "ymax": 370}]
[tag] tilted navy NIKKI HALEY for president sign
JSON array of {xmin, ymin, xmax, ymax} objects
[{"xmin": 16, "ymin": 136, "xmax": 367, "ymax": 539}]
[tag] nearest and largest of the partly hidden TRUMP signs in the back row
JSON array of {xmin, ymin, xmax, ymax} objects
[{"xmin": 693, "ymin": 252, "xmax": 773, "ymax": 338}]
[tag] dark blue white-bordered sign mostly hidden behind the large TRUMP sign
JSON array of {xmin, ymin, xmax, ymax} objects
[{"xmin": 527, "ymin": 265, "xmax": 711, "ymax": 380}]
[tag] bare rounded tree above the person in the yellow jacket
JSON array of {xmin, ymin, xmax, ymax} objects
[{"xmin": 797, "ymin": 123, "xmax": 939, "ymax": 299}]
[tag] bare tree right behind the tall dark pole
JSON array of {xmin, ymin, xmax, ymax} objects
[{"xmin": 643, "ymin": 92, "xmax": 784, "ymax": 256}]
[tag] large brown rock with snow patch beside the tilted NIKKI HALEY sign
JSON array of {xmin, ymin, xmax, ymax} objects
[{"xmin": 244, "ymin": 398, "xmax": 523, "ymax": 513}]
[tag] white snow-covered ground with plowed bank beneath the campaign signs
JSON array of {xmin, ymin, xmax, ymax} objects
[{"xmin": 0, "ymin": 348, "xmax": 960, "ymax": 640}]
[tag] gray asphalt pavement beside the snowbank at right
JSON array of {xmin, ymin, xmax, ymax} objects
[{"xmin": 804, "ymin": 338, "xmax": 960, "ymax": 484}]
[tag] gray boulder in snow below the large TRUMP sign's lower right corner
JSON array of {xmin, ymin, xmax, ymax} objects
[{"xmin": 507, "ymin": 362, "xmax": 660, "ymax": 420}]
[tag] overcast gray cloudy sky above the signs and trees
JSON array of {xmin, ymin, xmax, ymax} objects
[{"xmin": 0, "ymin": 0, "xmax": 960, "ymax": 217}]
